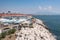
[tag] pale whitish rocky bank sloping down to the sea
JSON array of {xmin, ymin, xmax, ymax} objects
[{"xmin": 16, "ymin": 19, "xmax": 56, "ymax": 40}]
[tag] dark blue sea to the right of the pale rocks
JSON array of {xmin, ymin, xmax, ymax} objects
[{"xmin": 33, "ymin": 15, "xmax": 60, "ymax": 40}]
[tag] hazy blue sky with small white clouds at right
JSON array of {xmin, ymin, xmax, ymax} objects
[{"xmin": 0, "ymin": 0, "xmax": 60, "ymax": 14}]
